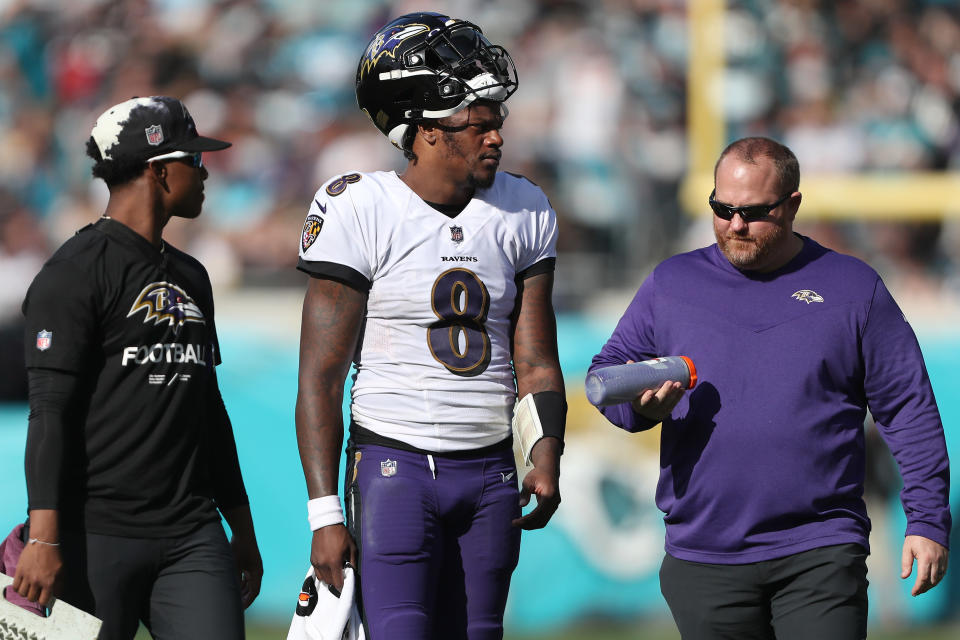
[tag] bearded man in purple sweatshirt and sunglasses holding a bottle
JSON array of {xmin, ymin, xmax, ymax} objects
[{"xmin": 590, "ymin": 138, "xmax": 951, "ymax": 640}]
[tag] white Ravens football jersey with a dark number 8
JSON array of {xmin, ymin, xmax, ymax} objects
[{"xmin": 299, "ymin": 171, "xmax": 557, "ymax": 452}]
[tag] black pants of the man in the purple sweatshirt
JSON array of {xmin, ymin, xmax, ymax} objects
[{"xmin": 660, "ymin": 544, "xmax": 867, "ymax": 640}]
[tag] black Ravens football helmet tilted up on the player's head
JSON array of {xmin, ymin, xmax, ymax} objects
[{"xmin": 357, "ymin": 12, "xmax": 517, "ymax": 149}]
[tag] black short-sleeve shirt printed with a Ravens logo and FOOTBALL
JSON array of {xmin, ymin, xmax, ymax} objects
[{"xmin": 23, "ymin": 218, "xmax": 225, "ymax": 537}]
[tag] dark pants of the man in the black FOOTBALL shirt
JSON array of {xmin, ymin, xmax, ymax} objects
[{"xmin": 60, "ymin": 522, "xmax": 244, "ymax": 640}]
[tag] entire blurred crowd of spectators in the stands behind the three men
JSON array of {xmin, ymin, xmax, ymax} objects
[{"xmin": 0, "ymin": 0, "xmax": 960, "ymax": 396}]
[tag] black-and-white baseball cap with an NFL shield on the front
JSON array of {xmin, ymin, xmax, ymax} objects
[{"xmin": 90, "ymin": 96, "xmax": 230, "ymax": 162}]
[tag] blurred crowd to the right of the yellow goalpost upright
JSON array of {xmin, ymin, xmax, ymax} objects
[{"xmin": 724, "ymin": 0, "xmax": 960, "ymax": 312}]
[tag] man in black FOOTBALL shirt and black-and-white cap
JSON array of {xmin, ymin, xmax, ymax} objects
[{"xmin": 14, "ymin": 96, "xmax": 263, "ymax": 640}]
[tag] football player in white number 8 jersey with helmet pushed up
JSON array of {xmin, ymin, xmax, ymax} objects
[{"xmin": 296, "ymin": 13, "xmax": 566, "ymax": 640}]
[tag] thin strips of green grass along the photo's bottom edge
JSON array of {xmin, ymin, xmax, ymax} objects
[{"xmin": 137, "ymin": 621, "xmax": 960, "ymax": 640}]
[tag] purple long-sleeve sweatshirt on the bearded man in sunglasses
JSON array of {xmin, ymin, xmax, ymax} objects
[{"xmin": 590, "ymin": 236, "xmax": 951, "ymax": 564}]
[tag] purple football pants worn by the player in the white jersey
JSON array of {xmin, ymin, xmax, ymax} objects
[{"xmin": 346, "ymin": 445, "xmax": 520, "ymax": 640}]
